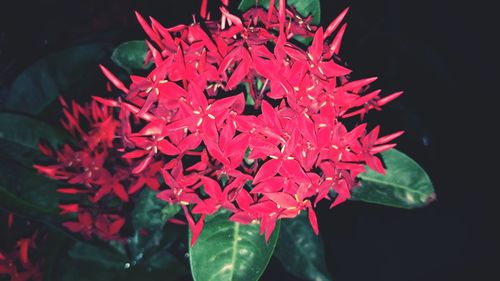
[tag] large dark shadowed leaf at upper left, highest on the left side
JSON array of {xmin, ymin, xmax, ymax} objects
[{"xmin": 2, "ymin": 43, "xmax": 109, "ymax": 115}]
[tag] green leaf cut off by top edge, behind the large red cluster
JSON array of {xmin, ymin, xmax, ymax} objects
[{"xmin": 238, "ymin": 0, "xmax": 321, "ymax": 25}]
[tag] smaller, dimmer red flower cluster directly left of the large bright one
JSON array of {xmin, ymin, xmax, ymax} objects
[{"xmin": 35, "ymin": 99, "xmax": 130, "ymax": 240}]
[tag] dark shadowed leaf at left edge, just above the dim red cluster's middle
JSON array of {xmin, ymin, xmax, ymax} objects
[{"xmin": 0, "ymin": 112, "xmax": 70, "ymax": 150}]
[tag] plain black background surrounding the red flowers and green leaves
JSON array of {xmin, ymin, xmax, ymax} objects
[{"xmin": 0, "ymin": 0, "xmax": 500, "ymax": 280}]
